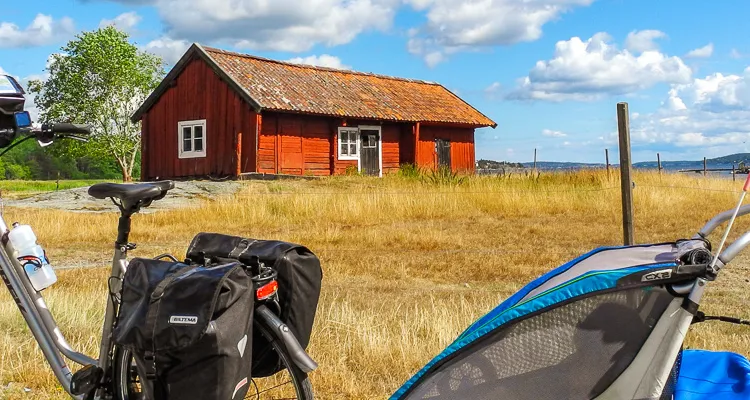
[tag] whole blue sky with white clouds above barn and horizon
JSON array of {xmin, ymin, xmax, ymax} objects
[{"xmin": 0, "ymin": 0, "xmax": 750, "ymax": 162}]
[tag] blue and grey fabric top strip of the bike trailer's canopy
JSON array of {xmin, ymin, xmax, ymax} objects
[{"xmin": 390, "ymin": 244, "xmax": 677, "ymax": 400}]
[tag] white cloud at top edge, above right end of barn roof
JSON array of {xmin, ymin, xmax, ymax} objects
[{"xmin": 404, "ymin": 0, "xmax": 594, "ymax": 66}]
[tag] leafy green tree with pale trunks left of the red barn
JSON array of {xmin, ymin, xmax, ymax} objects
[{"xmin": 29, "ymin": 26, "xmax": 164, "ymax": 181}]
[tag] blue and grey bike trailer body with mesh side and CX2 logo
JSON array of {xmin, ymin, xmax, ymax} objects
[{"xmin": 391, "ymin": 240, "xmax": 711, "ymax": 400}]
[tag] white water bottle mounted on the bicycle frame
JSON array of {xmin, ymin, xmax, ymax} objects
[{"xmin": 8, "ymin": 222, "xmax": 57, "ymax": 291}]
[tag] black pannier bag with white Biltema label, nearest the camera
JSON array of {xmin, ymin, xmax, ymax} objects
[{"xmin": 113, "ymin": 258, "xmax": 255, "ymax": 400}]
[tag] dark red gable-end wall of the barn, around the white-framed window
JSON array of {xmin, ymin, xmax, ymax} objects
[{"xmin": 141, "ymin": 59, "xmax": 256, "ymax": 180}]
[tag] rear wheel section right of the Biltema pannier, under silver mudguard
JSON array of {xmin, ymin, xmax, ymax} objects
[{"xmin": 250, "ymin": 320, "xmax": 314, "ymax": 400}]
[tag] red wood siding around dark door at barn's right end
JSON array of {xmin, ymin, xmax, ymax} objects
[{"xmin": 412, "ymin": 125, "xmax": 476, "ymax": 173}]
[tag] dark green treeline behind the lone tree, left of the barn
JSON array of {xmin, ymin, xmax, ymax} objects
[{"xmin": 0, "ymin": 140, "xmax": 140, "ymax": 180}]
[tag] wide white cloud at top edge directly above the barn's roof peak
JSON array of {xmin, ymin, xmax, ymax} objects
[{"xmin": 142, "ymin": 0, "xmax": 401, "ymax": 52}]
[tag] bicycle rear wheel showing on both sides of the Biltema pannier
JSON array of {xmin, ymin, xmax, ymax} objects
[{"xmin": 113, "ymin": 320, "xmax": 314, "ymax": 400}]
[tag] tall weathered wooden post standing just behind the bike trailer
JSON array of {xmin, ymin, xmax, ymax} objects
[{"xmin": 617, "ymin": 103, "xmax": 635, "ymax": 246}]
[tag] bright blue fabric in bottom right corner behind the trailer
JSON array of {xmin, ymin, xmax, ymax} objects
[{"xmin": 674, "ymin": 350, "xmax": 750, "ymax": 400}]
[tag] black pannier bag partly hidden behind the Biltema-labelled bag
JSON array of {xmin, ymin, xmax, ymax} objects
[{"xmin": 187, "ymin": 233, "xmax": 323, "ymax": 378}]
